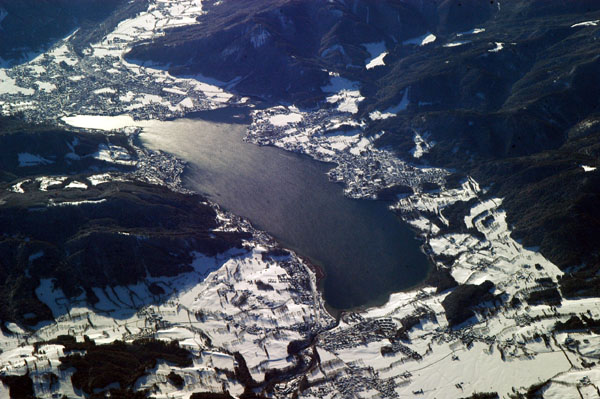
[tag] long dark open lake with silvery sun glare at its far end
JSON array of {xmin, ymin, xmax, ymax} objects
[{"xmin": 140, "ymin": 111, "xmax": 429, "ymax": 309}]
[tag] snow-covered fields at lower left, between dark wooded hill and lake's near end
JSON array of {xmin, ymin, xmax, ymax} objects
[{"xmin": 0, "ymin": 213, "xmax": 333, "ymax": 398}]
